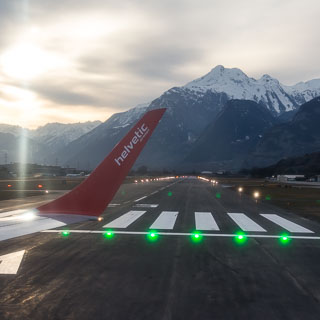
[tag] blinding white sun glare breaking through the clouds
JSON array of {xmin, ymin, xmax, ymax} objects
[{"xmin": 0, "ymin": 43, "xmax": 62, "ymax": 80}]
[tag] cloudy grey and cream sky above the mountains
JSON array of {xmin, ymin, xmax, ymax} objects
[{"xmin": 0, "ymin": 0, "xmax": 320, "ymax": 128}]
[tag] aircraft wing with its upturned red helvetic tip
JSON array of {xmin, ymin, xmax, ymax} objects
[{"xmin": 0, "ymin": 109, "xmax": 166, "ymax": 241}]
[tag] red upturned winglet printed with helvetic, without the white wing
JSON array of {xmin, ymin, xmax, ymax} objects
[{"xmin": 37, "ymin": 109, "xmax": 166, "ymax": 216}]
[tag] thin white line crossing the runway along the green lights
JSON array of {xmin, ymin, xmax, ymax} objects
[{"xmin": 41, "ymin": 229, "xmax": 320, "ymax": 240}]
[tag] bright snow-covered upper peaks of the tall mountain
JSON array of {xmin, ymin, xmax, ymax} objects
[{"xmin": 183, "ymin": 66, "xmax": 320, "ymax": 115}]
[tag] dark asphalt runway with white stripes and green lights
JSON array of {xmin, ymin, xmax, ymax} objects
[{"xmin": 0, "ymin": 179, "xmax": 320, "ymax": 320}]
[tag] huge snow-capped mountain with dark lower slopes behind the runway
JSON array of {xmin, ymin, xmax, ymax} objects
[{"xmin": 0, "ymin": 66, "xmax": 320, "ymax": 170}]
